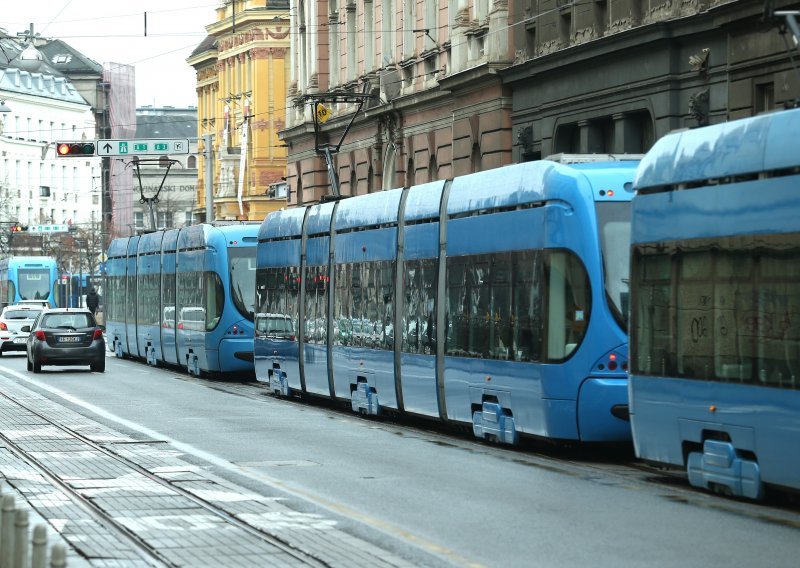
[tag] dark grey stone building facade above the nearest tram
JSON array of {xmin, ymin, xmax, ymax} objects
[{"xmin": 500, "ymin": 0, "xmax": 800, "ymax": 162}]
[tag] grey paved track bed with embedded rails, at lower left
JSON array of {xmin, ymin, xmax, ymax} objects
[{"xmin": 0, "ymin": 371, "xmax": 414, "ymax": 568}]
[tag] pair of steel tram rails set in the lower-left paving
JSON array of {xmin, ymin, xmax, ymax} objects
[{"xmin": 0, "ymin": 393, "xmax": 330, "ymax": 568}]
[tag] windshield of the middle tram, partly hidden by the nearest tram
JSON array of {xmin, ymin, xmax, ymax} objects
[{"xmin": 597, "ymin": 201, "xmax": 631, "ymax": 331}]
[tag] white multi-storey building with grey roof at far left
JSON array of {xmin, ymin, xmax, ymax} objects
[{"xmin": 0, "ymin": 32, "xmax": 102, "ymax": 246}]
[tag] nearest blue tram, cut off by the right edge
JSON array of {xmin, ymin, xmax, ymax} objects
[{"xmin": 630, "ymin": 110, "xmax": 800, "ymax": 499}]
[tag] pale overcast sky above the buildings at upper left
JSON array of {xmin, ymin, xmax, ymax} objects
[{"xmin": 0, "ymin": 0, "xmax": 221, "ymax": 107}]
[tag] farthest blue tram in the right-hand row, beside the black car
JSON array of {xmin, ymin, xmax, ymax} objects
[{"xmin": 106, "ymin": 224, "xmax": 259, "ymax": 376}]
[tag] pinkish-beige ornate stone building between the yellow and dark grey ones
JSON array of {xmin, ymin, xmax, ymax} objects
[{"xmin": 282, "ymin": 0, "xmax": 514, "ymax": 205}]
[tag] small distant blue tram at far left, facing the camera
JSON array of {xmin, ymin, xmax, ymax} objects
[{"xmin": 0, "ymin": 256, "xmax": 58, "ymax": 309}]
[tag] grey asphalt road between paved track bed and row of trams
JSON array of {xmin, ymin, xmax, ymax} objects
[{"xmin": 0, "ymin": 354, "xmax": 800, "ymax": 568}]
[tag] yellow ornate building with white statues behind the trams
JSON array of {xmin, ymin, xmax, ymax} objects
[{"xmin": 187, "ymin": 0, "xmax": 290, "ymax": 221}]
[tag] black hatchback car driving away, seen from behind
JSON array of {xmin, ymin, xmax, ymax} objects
[{"xmin": 26, "ymin": 308, "xmax": 106, "ymax": 373}]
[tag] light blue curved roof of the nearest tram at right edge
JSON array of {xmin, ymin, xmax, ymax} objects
[{"xmin": 634, "ymin": 109, "xmax": 800, "ymax": 190}]
